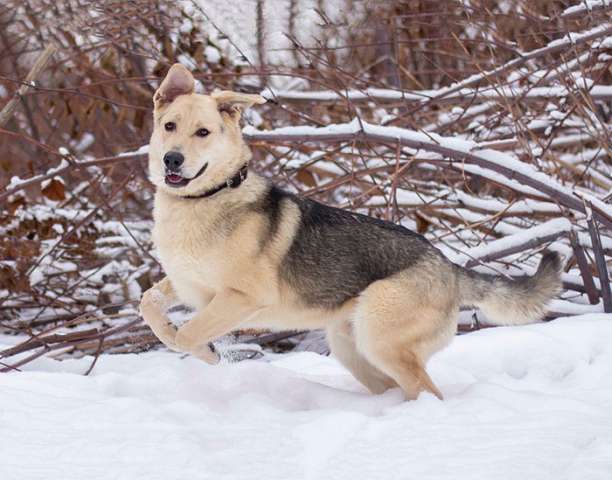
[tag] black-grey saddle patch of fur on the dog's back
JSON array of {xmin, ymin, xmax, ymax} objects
[{"xmin": 281, "ymin": 187, "xmax": 437, "ymax": 308}]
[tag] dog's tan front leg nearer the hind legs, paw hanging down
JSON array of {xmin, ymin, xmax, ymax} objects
[{"xmin": 175, "ymin": 289, "xmax": 259, "ymax": 364}]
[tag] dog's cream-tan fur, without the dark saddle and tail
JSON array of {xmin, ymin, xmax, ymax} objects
[{"xmin": 140, "ymin": 66, "xmax": 556, "ymax": 398}]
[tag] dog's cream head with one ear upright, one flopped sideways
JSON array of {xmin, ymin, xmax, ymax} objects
[{"xmin": 149, "ymin": 63, "xmax": 265, "ymax": 196}]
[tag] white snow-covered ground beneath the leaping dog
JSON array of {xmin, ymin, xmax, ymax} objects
[{"xmin": 0, "ymin": 314, "xmax": 612, "ymax": 480}]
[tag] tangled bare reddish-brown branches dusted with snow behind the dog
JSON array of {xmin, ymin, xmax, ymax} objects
[{"xmin": 0, "ymin": 0, "xmax": 612, "ymax": 369}]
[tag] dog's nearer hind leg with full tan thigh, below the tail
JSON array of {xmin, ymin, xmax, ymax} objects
[{"xmin": 354, "ymin": 265, "xmax": 458, "ymax": 399}]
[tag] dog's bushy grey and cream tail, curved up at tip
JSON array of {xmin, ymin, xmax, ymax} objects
[{"xmin": 459, "ymin": 251, "xmax": 562, "ymax": 325}]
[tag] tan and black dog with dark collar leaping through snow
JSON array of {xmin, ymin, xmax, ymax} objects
[{"xmin": 140, "ymin": 64, "xmax": 562, "ymax": 399}]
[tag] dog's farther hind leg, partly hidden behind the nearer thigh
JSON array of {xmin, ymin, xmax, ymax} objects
[{"xmin": 326, "ymin": 321, "xmax": 397, "ymax": 394}]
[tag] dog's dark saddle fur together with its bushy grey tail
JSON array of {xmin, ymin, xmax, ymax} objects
[{"xmin": 261, "ymin": 186, "xmax": 561, "ymax": 324}]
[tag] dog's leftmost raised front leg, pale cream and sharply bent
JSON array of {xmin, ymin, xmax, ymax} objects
[{"xmin": 140, "ymin": 277, "xmax": 178, "ymax": 350}]
